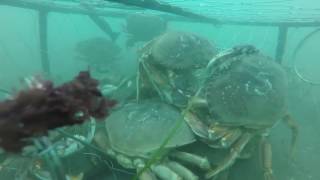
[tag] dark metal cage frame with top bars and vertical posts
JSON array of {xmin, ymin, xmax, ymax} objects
[{"xmin": 0, "ymin": 0, "xmax": 320, "ymax": 76}]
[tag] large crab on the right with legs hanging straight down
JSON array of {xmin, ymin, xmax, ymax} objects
[{"xmin": 185, "ymin": 45, "xmax": 298, "ymax": 180}]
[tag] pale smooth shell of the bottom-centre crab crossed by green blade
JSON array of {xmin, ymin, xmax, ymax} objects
[{"xmin": 106, "ymin": 101, "xmax": 195, "ymax": 158}]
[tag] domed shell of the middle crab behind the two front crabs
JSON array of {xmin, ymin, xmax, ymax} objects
[{"xmin": 146, "ymin": 32, "xmax": 216, "ymax": 69}]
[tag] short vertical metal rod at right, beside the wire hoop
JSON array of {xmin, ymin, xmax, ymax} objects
[{"xmin": 275, "ymin": 26, "xmax": 288, "ymax": 64}]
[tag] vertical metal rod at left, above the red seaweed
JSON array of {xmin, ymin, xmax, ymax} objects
[{"xmin": 38, "ymin": 10, "xmax": 50, "ymax": 76}]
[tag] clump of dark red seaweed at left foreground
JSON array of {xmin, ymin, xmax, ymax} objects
[{"xmin": 0, "ymin": 71, "xmax": 116, "ymax": 152}]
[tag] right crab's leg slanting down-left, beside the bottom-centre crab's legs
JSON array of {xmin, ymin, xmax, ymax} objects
[{"xmin": 206, "ymin": 132, "xmax": 253, "ymax": 179}]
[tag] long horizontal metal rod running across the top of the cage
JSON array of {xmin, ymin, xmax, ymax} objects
[{"xmin": 0, "ymin": 0, "xmax": 320, "ymax": 27}]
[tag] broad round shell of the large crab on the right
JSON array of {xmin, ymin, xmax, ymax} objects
[{"xmin": 205, "ymin": 51, "xmax": 288, "ymax": 128}]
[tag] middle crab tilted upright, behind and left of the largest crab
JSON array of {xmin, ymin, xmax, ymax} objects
[{"xmin": 137, "ymin": 32, "xmax": 216, "ymax": 107}]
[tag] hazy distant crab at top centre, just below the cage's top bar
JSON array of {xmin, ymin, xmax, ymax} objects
[{"xmin": 125, "ymin": 13, "xmax": 167, "ymax": 47}]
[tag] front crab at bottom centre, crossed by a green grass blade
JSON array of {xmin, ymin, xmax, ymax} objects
[{"xmin": 94, "ymin": 100, "xmax": 216, "ymax": 180}]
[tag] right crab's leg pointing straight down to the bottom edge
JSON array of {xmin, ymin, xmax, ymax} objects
[{"xmin": 260, "ymin": 138, "xmax": 274, "ymax": 180}]
